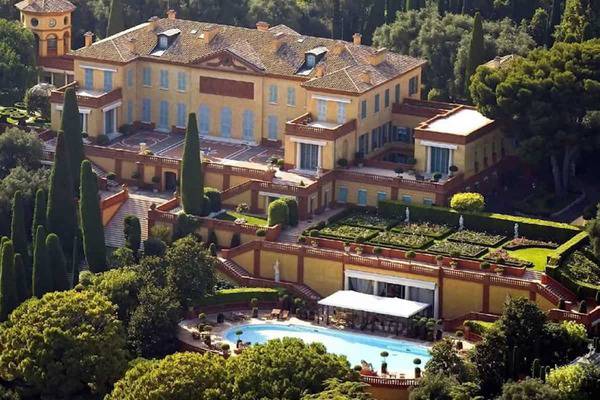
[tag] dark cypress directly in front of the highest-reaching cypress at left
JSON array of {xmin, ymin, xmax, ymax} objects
[{"xmin": 47, "ymin": 130, "xmax": 79, "ymax": 254}]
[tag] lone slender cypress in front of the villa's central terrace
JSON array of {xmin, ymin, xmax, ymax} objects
[{"xmin": 179, "ymin": 113, "xmax": 204, "ymax": 216}]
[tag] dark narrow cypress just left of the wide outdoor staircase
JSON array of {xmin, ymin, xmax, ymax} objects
[{"xmin": 79, "ymin": 160, "xmax": 106, "ymax": 272}]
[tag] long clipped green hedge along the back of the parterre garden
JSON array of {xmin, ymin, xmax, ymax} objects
[{"xmin": 379, "ymin": 200, "xmax": 581, "ymax": 243}]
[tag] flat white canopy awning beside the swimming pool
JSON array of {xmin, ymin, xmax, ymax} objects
[{"xmin": 319, "ymin": 290, "xmax": 429, "ymax": 318}]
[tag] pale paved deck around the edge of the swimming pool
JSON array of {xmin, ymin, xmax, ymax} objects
[{"xmin": 177, "ymin": 311, "xmax": 473, "ymax": 379}]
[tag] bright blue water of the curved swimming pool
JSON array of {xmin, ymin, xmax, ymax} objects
[{"xmin": 224, "ymin": 324, "xmax": 431, "ymax": 373}]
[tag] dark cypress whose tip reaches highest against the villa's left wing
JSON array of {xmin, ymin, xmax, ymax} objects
[{"xmin": 61, "ymin": 88, "xmax": 84, "ymax": 194}]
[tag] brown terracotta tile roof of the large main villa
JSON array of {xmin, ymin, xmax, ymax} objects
[{"xmin": 71, "ymin": 18, "xmax": 426, "ymax": 93}]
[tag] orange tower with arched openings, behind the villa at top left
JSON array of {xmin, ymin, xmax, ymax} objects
[{"xmin": 15, "ymin": 0, "xmax": 75, "ymax": 59}]
